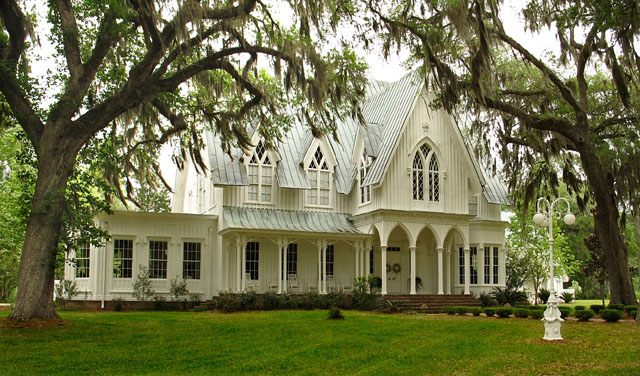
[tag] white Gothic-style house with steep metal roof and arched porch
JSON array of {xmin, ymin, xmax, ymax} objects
[{"xmin": 66, "ymin": 74, "xmax": 507, "ymax": 301}]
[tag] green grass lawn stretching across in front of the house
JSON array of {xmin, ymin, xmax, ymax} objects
[{"xmin": 0, "ymin": 311, "xmax": 640, "ymax": 376}]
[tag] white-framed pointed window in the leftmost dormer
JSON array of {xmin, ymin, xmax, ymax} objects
[{"xmin": 245, "ymin": 140, "xmax": 275, "ymax": 204}]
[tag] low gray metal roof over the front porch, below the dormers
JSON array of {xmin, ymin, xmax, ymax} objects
[{"xmin": 222, "ymin": 206, "xmax": 362, "ymax": 234}]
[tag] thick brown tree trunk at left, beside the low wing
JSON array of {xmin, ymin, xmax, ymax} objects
[{"xmin": 9, "ymin": 135, "xmax": 79, "ymax": 321}]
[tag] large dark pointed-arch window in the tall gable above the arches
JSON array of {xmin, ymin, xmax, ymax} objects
[{"xmin": 411, "ymin": 144, "xmax": 440, "ymax": 202}]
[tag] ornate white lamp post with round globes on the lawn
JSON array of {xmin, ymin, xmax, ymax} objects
[{"xmin": 533, "ymin": 197, "xmax": 576, "ymax": 341}]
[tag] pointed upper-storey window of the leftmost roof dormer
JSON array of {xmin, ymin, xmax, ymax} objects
[{"xmin": 247, "ymin": 141, "xmax": 273, "ymax": 203}]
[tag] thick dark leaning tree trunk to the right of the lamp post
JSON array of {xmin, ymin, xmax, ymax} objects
[{"xmin": 580, "ymin": 135, "xmax": 636, "ymax": 305}]
